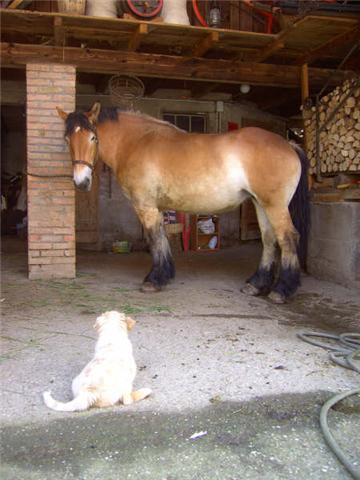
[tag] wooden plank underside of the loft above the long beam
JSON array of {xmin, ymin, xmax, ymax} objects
[{"xmin": 1, "ymin": 9, "xmax": 359, "ymax": 61}]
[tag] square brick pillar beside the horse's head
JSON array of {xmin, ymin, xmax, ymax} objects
[{"xmin": 26, "ymin": 63, "xmax": 76, "ymax": 279}]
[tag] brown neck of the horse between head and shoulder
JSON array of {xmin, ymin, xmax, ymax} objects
[{"xmin": 97, "ymin": 115, "xmax": 146, "ymax": 171}]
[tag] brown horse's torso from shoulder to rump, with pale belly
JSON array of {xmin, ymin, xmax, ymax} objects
[{"xmin": 125, "ymin": 127, "xmax": 300, "ymax": 213}]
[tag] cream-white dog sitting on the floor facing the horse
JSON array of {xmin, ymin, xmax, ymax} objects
[{"xmin": 43, "ymin": 311, "xmax": 151, "ymax": 412}]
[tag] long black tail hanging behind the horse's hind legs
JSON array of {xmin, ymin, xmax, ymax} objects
[{"xmin": 289, "ymin": 142, "xmax": 310, "ymax": 271}]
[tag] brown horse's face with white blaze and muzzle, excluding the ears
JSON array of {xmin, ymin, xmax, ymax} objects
[{"xmin": 69, "ymin": 126, "xmax": 96, "ymax": 191}]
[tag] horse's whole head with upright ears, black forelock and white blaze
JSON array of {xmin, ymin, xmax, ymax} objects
[{"xmin": 56, "ymin": 103, "xmax": 101, "ymax": 191}]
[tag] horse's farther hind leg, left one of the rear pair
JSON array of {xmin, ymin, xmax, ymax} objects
[{"xmin": 242, "ymin": 200, "xmax": 276, "ymax": 295}]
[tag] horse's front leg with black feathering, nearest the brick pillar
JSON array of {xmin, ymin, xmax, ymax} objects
[{"xmin": 135, "ymin": 208, "xmax": 175, "ymax": 292}]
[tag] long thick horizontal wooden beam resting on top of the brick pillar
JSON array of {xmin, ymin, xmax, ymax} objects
[{"xmin": 0, "ymin": 42, "xmax": 349, "ymax": 88}]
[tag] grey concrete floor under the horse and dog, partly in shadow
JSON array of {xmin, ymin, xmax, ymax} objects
[{"xmin": 0, "ymin": 241, "xmax": 360, "ymax": 480}]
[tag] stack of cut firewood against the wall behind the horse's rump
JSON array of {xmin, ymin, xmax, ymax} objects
[{"xmin": 303, "ymin": 79, "xmax": 360, "ymax": 174}]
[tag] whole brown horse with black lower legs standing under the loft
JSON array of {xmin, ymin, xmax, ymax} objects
[{"xmin": 58, "ymin": 103, "xmax": 308, "ymax": 303}]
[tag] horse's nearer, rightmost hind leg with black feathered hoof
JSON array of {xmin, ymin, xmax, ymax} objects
[{"xmin": 265, "ymin": 206, "xmax": 300, "ymax": 303}]
